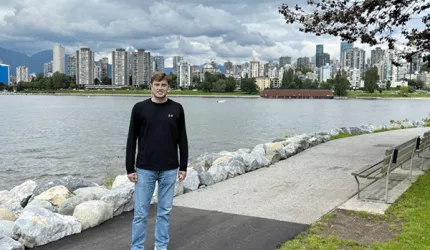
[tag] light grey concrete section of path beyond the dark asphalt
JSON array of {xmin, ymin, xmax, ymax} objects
[{"xmin": 174, "ymin": 128, "xmax": 430, "ymax": 224}]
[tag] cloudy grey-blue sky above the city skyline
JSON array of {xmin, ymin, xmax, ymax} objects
[{"xmin": 0, "ymin": 0, "xmax": 424, "ymax": 67}]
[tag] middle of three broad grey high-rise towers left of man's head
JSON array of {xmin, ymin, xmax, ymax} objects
[{"xmin": 112, "ymin": 49, "xmax": 129, "ymax": 85}]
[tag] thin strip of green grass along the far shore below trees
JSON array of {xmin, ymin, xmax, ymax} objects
[{"xmin": 22, "ymin": 90, "xmax": 260, "ymax": 96}]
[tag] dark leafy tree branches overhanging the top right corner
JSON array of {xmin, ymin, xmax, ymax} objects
[{"xmin": 279, "ymin": 0, "xmax": 430, "ymax": 64}]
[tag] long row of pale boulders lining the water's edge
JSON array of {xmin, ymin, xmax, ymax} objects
[{"xmin": 0, "ymin": 115, "xmax": 430, "ymax": 250}]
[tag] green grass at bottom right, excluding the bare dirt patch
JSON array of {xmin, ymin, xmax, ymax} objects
[{"xmin": 279, "ymin": 172, "xmax": 430, "ymax": 250}]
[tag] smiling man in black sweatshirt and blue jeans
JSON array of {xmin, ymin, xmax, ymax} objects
[{"xmin": 126, "ymin": 72, "xmax": 188, "ymax": 250}]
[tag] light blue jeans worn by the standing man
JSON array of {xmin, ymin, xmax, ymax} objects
[{"xmin": 131, "ymin": 169, "xmax": 178, "ymax": 250}]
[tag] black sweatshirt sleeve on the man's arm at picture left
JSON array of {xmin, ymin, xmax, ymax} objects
[{"xmin": 125, "ymin": 105, "xmax": 139, "ymax": 174}]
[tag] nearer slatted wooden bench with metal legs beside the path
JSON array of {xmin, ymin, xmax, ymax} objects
[{"xmin": 351, "ymin": 136, "xmax": 420, "ymax": 203}]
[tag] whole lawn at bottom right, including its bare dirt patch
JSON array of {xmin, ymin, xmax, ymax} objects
[{"xmin": 279, "ymin": 169, "xmax": 430, "ymax": 250}]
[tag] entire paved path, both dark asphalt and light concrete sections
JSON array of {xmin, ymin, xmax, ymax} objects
[{"xmin": 36, "ymin": 128, "xmax": 430, "ymax": 250}]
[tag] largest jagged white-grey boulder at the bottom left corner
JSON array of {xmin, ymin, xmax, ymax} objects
[{"xmin": 13, "ymin": 207, "xmax": 81, "ymax": 248}]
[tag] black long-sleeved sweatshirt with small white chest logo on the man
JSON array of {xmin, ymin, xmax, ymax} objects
[{"xmin": 125, "ymin": 98, "xmax": 188, "ymax": 174}]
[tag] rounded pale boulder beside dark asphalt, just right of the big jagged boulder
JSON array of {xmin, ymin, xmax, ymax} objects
[{"xmin": 73, "ymin": 200, "xmax": 113, "ymax": 230}]
